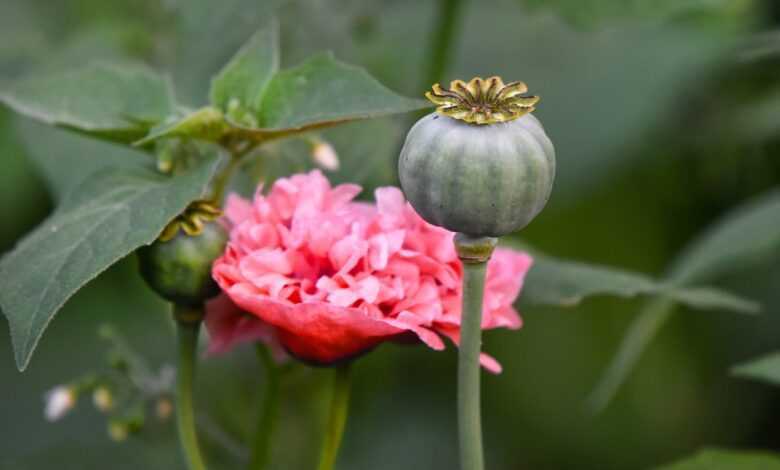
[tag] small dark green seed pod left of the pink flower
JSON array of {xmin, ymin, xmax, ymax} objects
[{"xmin": 138, "ymin": 204, "xmax": 228, "ymax": 305}]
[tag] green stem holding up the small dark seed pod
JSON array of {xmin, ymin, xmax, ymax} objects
[{"xmin": 174, "ymin": 305, "xmax": 206, "ymax": 470}]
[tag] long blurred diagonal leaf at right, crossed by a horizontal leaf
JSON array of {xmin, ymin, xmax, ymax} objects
[{"xmin": 589, "ymin": 190, "xmax": 780, "ymax": 409}]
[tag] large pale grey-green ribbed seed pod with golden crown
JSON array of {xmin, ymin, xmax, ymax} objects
[{"xmin": 398, "ymin": 77, "xmax": 555, "ymax": 237}]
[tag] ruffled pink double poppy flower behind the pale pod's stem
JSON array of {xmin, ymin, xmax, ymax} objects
[{"xmin": 206, "ymin": 171, "xmax": 532, "ymax": 372}]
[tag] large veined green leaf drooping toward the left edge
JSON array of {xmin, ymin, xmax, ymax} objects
[{"xmin": 0, "ymin": 156, "xmax": 216, "ymax": 370}]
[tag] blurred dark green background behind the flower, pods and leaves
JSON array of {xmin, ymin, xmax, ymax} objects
[{"xmin": 0, "ymin": 0, "xmax": 780, "ymax": 470}]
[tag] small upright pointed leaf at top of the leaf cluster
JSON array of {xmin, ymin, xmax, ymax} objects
[{"xmin": 209, "ymin": 21, "xmax": 279, "ymax": 111}]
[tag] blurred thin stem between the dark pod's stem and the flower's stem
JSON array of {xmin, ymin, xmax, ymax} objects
[{"xmin": 249, "ymin": 344, "xmax": 280, "ymax": 470}]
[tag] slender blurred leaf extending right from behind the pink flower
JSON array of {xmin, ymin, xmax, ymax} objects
[{"xmin": 521, "ymin": 254, "xmax": 758, "ymax": 313}]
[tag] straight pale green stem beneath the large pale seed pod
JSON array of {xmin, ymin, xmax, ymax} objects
[{"xmin": 455, "ymin": 233, "xmax": 496, "ymax": 470}]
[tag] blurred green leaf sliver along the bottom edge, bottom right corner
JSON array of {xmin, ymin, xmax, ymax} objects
[{"xmin": 656, "ymin": 449, "xmax": 780, "ymax": 470}]
